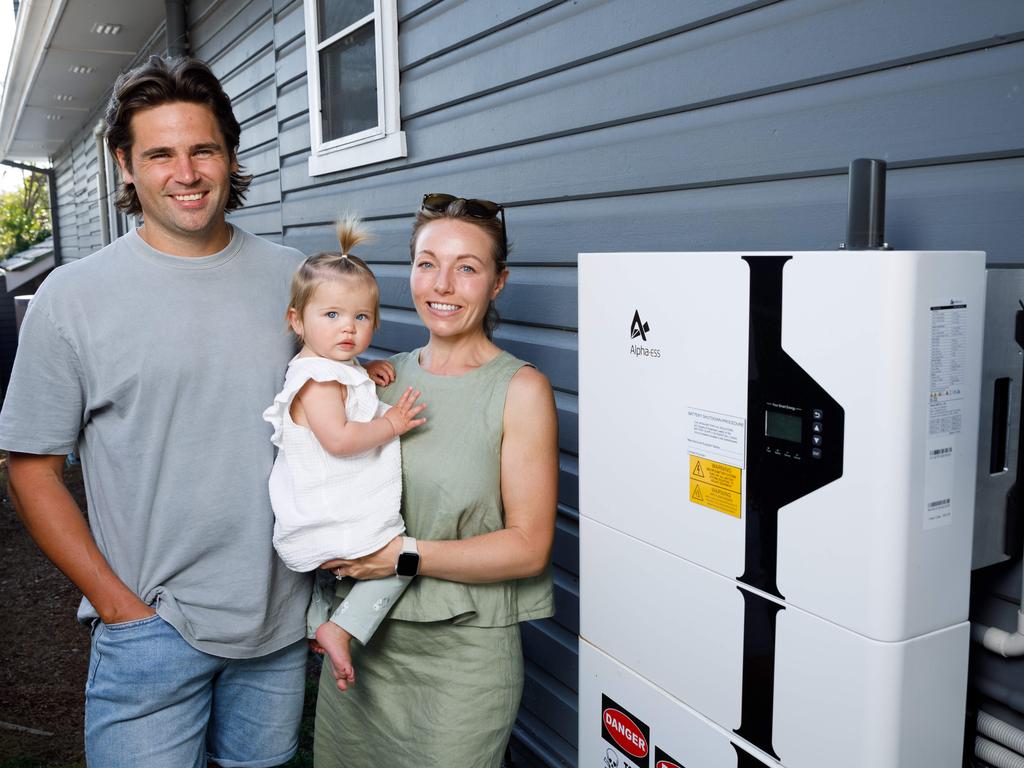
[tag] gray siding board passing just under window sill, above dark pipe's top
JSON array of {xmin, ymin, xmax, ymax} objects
[{"xmin": 272, "ymin": 43, "xmax": 1024, "ymax": 219}]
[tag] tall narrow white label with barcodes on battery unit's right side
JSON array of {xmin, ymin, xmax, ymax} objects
[{"xmin": 924, "ymin": 300, "xmax": 968, "ymax": 530}]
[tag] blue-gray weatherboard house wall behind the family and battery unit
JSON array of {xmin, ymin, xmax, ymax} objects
[{"xmin": 46, "ymin": 0, "xmax": 1024, "ymax": 765}]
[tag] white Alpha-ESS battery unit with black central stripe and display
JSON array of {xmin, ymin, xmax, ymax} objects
[{"xmin": 579, "ymin": 251, "xmax": 985, "ymax": 768}]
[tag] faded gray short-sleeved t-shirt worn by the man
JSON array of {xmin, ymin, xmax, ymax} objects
[{"xmin": 0, "ymin": 227, "xmax": 311, "ymax": 658}]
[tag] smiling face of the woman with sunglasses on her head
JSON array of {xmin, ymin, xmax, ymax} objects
[{"xmin": 410, "ymin": 218, "xmax": 508, "ymax": 337}]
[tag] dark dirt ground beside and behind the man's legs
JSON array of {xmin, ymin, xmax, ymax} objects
[{"xmin": 0, "ymin": 454, "xmax": 318, "ymax": 768}]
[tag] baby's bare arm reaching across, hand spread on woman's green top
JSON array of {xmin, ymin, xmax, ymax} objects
[{"xmin": 292, "ymin": 380, "xmax": 427, "ymax": 456}]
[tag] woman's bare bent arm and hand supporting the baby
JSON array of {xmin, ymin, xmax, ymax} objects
[{"xmin": 323, "ymin": 367, "xmax": 558, "ymax": 584}]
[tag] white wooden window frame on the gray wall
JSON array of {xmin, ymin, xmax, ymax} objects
[{"xmin": 303, "ymin": 0, "xmax": 408, "ymax": 176}]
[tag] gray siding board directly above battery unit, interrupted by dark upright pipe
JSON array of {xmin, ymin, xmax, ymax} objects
[{"xmin": 285, "ymin": 157, "xmax": 1024, "ymax": 264}]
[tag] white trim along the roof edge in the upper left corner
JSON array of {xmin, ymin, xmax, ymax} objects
[{"xmin": 0, "ymin": 0, "xmax": 68, "ymax": 159}]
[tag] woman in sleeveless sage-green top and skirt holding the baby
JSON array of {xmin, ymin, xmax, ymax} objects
[{"xmin": 314, "ymin": 195, "xmax": 558, "ymax": 768}]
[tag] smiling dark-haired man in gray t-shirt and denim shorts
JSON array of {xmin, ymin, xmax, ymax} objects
[{"xmin": 0, "ymin": 56, "xmax": 310, "ymax": 768}]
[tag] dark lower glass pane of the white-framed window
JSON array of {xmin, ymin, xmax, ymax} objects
[{"xmin": 321, "ymin": 24, "xmax": 377, "ymax": 141}]
